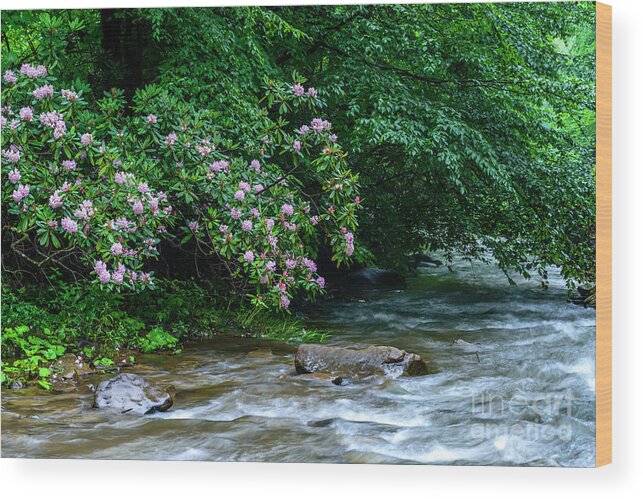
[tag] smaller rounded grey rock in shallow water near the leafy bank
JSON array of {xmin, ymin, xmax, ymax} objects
[{"xmin": 94, "ymin": 373, "xmax": 173, "ymax": 414}]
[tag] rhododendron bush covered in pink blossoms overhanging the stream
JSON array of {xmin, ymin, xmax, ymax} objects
[{"xmin": 1, "ymin": 64, "xmax": 360, "ymax": 309}]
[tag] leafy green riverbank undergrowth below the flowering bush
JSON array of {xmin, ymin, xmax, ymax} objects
[{"xmin": 0, "ymin": 280, "xmax": 326, "ymax": 390}]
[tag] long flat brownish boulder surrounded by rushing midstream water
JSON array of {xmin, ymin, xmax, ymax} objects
[{"xmin": 295, "ymin": 344, "xmax": 428, "ymax": 377}]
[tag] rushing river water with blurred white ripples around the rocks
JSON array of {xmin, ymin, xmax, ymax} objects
[{"xmin": 2, "ymin": 262, "xmax": 595, "ymax": 466}]
